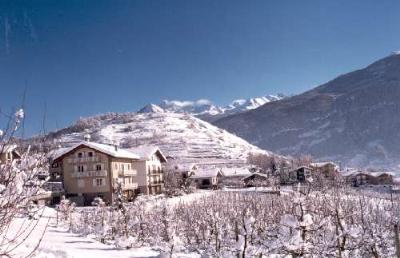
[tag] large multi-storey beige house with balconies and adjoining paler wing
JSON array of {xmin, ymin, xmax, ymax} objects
[{"xmin": 50, "ymin": 141, "xmax": 166, "ymax": 205}]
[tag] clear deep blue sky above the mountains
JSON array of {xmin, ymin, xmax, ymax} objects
[{"xmin": 0, "ymin": 0, "xmax": 400, "ymax": 134}]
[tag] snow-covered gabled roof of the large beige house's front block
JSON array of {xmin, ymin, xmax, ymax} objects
[{"xmin": 52, "ymin": 142, "xmax": 140, "ymax": 159}]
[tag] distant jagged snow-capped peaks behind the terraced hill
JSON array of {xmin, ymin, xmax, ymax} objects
[{"xmin": 152, "ymin": 94, "xmax": 286, "ymax": 122}]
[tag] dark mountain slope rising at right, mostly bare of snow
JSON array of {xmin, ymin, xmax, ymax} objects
[{"xmin": 215, "ymin": 54, "xmax": 400, "ymax": 169}]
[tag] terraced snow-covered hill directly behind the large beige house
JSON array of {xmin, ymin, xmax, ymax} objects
[{"xmin": 49, "ymin": 112, "xmax": 269, "ymax": 165}]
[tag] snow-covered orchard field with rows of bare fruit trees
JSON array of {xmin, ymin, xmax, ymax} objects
[{"xmin": 10, "ymin": 188, "xmax": 400, "ymax": 258}]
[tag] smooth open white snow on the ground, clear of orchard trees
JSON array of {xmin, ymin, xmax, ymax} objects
[{"xmin": 7, "ymin": 191, "xmax": 211, "ymax": 258}]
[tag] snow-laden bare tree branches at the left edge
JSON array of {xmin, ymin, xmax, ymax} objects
[{"xmin": 0, "ymin": 106, "xmax": 47, "ymax": 257}]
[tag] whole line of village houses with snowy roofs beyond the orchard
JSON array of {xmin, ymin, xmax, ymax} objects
[{"xmin": 0, "ymin": 139, "xmax": 394, "ymax": 205}]
